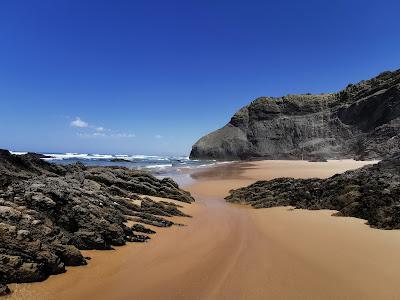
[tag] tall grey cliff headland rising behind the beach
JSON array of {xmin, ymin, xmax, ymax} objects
[{"xmin": 190, "ymin": 70, "xmax": 400, "ymax": 160}]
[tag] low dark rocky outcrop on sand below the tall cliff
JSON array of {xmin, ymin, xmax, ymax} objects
[{"xmin": 226, "ymin": 153, "xmax": 400, "ymax": 229}]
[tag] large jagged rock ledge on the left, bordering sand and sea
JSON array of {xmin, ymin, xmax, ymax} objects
[{"xmin": 0, "ymin": 150, "xmax": 194, "ymax": 295}]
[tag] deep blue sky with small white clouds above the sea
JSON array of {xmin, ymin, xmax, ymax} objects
[{"xmin": 0, "ymin": 0, "xmax": 400, "ymax": 154}]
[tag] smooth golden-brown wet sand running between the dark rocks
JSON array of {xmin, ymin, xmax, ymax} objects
[{"xmin": 6, "ymin": 161, "xmax": 400, "ymax": 300}]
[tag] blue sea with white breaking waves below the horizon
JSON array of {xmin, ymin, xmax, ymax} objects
[{"xmin": 12, "ymin": 152, "xmax": 221, "ymax": 185}]
